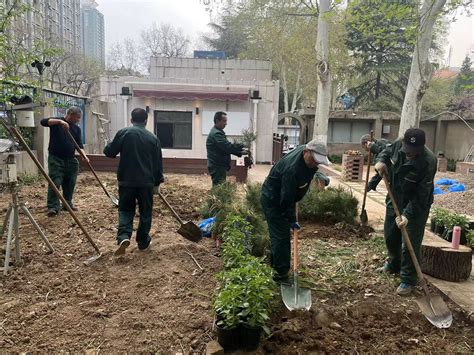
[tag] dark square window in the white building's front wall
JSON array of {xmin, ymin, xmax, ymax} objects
[{"xmin": 155, "ymin": 111, "xmax": 193, "ymax": 149}]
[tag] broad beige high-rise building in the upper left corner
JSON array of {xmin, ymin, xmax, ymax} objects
[{"xmin": 6, "ymin": 0, "xmax": 81, "ymax": 53}]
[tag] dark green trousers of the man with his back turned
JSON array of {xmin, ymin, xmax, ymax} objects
[{"xmin": 117, "ymin": 186, "xmax": 153, "ymax": 249}]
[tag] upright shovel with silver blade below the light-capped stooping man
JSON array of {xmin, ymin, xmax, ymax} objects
[{"xmin": 281, "ymin": 213, "xmax": 311, "ymax": 311}]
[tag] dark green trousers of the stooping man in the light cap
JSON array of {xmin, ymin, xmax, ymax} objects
[{"xmin": 260, "ymin": 196, "xmax": 291, "ymax": 279}]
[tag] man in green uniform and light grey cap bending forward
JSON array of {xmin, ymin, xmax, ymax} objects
[{"xmin": 260, "ymin": 141, "xmax": 329, "ymax": 282}]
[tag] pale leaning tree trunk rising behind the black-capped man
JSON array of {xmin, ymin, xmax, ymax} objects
[{"xmin": 398, "ymin": 0, "xmax": 446, "ymax": 137}]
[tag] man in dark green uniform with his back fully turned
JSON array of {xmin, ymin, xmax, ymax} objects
[{"xmin": 104, "ymin": 108, "xmax": 164, "ymax": 255}]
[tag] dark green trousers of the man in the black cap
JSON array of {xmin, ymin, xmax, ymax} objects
[{"xmin": 384, "ymin": 202, "xmax": 429, "ymax": 286}]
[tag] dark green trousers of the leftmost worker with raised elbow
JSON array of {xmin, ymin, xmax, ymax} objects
[{"xmin": 47, "ymin": 154, "xmax": 79, "ymax": 211}]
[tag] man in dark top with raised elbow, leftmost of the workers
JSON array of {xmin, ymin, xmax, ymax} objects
[{"xmin": 40, "ymin": 106, "xmax": 89, "ymax": 217}]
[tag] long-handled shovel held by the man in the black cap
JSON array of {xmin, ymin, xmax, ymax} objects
[{"xmin": 382, "ymin": 172, "xmax": 453, "ymax": 328}]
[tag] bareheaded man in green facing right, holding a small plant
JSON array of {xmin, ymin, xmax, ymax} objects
[{"xmin": 206, "ymin": 111, "xmax": 248, "ymax": 187}]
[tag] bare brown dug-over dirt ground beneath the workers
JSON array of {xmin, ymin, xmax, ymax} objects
[{"xmin": 0, "ymin": 173, "xmax": 474, "ymax": 354}]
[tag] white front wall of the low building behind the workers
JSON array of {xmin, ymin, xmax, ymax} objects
[{"xmin": 100, "ymin": 58, "xmax": 279, "ymax": 162}]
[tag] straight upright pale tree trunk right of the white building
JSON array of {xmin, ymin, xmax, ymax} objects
[{"xmin": 313, "ymin": 0, "xmax": 331, "ymax": 144}]
